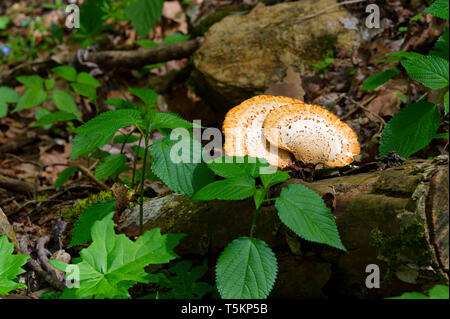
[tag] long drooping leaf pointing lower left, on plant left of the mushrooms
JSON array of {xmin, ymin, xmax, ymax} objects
[{"xmin": 70, "ymin": 109, "xmax": 141, "ymax": 159}]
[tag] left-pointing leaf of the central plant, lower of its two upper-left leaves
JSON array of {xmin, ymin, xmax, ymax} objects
[{"xmin": 192, "ymin": 177, "xmax": 256, "ymax": 201}]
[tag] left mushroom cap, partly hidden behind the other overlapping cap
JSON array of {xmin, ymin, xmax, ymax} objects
[{"xmin": 222, "ymin": 95, "xmax": 301, "ymax": 168}]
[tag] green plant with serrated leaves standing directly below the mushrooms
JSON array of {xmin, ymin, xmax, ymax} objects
[{"xmin": 190, "ymin": 156, "xmax": 345, "ymax": 298}]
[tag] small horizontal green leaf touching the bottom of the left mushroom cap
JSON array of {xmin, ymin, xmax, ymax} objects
[{"xmin": 207, "ymin": 156, "xmax": 269, "ymax": 178}]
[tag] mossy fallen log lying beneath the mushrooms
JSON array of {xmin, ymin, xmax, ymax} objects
[{"xmin": 120, "ymin": 156, "xmax": 449, "ymax": 298}]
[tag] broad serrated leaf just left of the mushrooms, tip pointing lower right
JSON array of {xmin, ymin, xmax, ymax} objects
[{"xmin": 151, "ymin": 136, "xmax": 214, "ymax": 196}]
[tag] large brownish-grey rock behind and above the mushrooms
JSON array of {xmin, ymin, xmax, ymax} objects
[{"xmin": 191, "ymin": 0, "xmax": 356, "ymax": 111}]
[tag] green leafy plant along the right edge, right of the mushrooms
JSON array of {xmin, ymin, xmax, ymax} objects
[{"xmin": 362, "ymin": 0, "xmax": 449, "ymax": 157}]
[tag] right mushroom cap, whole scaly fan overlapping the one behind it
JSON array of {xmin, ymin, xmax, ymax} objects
[{"xmin": 264, "ymin": 102, "xmax": 359, "ymax": 167}]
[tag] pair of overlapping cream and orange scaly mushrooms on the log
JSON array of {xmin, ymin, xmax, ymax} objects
[{"xmin": 222, "ymin": 95, "xmax": 359, "ymax": 169}]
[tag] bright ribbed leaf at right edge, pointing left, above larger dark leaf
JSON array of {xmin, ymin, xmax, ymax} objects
[{"xmin": 402, "ymin": 56, "xmax": 449, "ymax": 89}]
